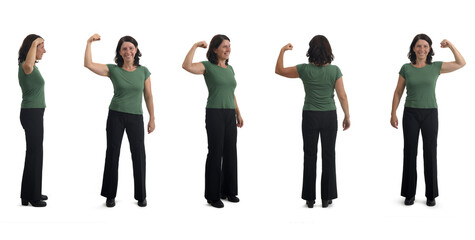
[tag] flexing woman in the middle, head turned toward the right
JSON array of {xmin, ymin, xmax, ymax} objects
[{"xmin": 182, "ymin": 35, "xmax": 244, "ymax": 208}]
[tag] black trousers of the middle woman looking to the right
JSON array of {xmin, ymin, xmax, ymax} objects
[{"xmin": 205, "ymin": 108, "xmax": 238, "ymax": 200}]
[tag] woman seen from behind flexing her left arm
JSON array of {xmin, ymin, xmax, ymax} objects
[{"xmin": 275, "ymin": 35, "xmax": 350, "ymax": 208}]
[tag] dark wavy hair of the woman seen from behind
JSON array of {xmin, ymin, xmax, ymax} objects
[{"xmin": 307, "ymin": 35, "xmax": 335, "ymax": 66}]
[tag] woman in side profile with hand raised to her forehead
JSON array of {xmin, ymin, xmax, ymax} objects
[{"xmin": 18, "ymin": 34, "xmax": 48, "ymax": 207}]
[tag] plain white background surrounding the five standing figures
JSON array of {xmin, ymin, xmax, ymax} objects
[{"xmin": 0, "ymin": 0, "xmax": 475, "ymax": 239}]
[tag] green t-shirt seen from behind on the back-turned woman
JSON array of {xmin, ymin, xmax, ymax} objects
[{"xmin": 297, "ymin": 63, "xmax": 343, "ymax": 111}]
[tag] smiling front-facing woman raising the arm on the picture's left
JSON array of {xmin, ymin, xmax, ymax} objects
[{"xmin": 84, "ymin": 34, "xmax": 155, "ymax": 207}]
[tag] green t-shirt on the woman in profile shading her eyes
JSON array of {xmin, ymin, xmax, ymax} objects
[{"xmin": 18, "ymin": 63, "xmax": 46, "ymax": 108}]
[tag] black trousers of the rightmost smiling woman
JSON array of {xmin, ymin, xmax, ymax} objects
[{"xmin": 401, "ymin": 107, "xmax": 439, "ymax": 199}]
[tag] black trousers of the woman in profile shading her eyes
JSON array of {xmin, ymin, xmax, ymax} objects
[{"xmin": 20, "ymin": 108, "xmax": 45, "ymax": 202}]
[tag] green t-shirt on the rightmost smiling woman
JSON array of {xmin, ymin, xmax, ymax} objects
[{"xmin": 399, "ymin": 62, "xmax": 442, "ymax": 108}]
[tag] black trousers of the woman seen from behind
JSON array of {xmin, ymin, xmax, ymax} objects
[{"xmin": 302, "ymin": 111, "xmax": 338, "ymax": 201}]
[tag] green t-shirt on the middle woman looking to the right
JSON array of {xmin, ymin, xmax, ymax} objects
[{"xmin": 201, "ymin": 61, "xmax": 236, "ymax": 109}]
